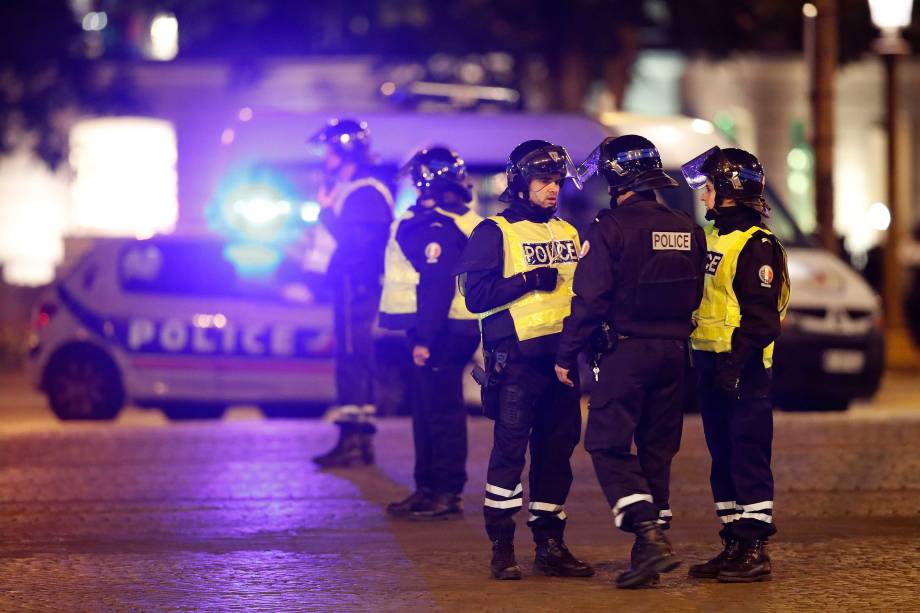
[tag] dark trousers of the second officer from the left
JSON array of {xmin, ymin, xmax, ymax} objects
[{"xmin": 411, "ymin": 333, "xmax": 479, "ymax": 494}]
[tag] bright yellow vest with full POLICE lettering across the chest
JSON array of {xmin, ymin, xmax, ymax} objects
[{"xmin": 479, "ymin": 215, "xmax": 581, "ymax": 341}]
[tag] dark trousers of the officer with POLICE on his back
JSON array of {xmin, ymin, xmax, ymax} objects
[{"xmin": 585, "ymin": 338, "xmax": 689, "ymax": 531}]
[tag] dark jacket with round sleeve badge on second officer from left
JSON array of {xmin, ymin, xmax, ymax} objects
[{"xmin": 396, "ymin": 201, "xmax": 479, "ymax": 347}]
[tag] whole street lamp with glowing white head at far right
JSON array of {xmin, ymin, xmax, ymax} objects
[{"xmin": 869, "ymin": 0, "xmax": 914, "ymax": 342}]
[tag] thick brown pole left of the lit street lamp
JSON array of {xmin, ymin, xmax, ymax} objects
[{"xmin": 806, "ymin": 0, "xmax": 840, "ymax": 253}]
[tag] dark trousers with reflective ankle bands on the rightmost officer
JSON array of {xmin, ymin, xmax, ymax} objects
[{"xmin": 693, "ymin": 351, "xmax": 776, "ymax": 539}]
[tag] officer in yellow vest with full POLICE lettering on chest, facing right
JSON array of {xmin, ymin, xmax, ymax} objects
[{"xmin": 458, "ymin": 140, "xmax": 594, "ymax": 579}]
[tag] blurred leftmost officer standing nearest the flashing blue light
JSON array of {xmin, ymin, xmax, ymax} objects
[{"xmin": 309, "ymin": 119, "xmax": 393, "ymax": 467}]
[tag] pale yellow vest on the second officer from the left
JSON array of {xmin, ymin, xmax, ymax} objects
[{"xmin": 380, "ymin": 207, "xmax": 482, "ymax": 328}]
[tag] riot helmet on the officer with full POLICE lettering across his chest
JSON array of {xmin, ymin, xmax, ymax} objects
[{"xmin": 499, "ymin": 140, "xmax": 581, "ymax": 202}]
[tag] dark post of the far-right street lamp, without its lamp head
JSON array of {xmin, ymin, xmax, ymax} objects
[{"xmin": 882, "ymin": 53, "xmax": 905, "ymax": 330}]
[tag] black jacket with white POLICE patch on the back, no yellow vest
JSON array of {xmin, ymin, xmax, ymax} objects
[{"xmin": 556, "ymin": 194, "xmax": 706, "ymax": 368}]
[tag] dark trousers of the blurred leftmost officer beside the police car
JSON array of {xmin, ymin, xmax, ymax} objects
[{"xmin": 333, "ymin": 277, "xmax": 380, "ymax": 422}]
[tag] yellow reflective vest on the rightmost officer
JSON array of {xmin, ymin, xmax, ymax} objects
[{"xmin": 690, "ymin": 226, "xmax": 790, "ymax": 368}]
